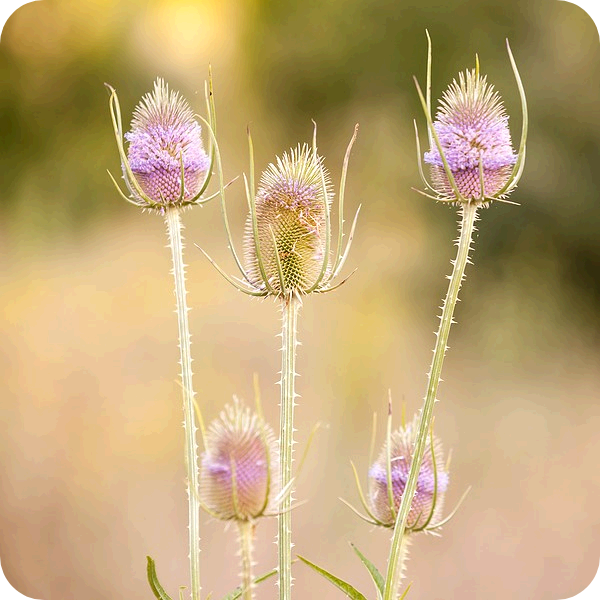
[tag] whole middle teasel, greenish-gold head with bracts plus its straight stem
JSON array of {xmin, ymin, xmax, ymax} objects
[{"xmin": 203, "ymin": 124, "xmax": 360, "ymax": 600}]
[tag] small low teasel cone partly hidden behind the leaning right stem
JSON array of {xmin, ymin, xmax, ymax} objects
[{"xmin": 368, "ymin": 417, "xmax": 448, "ymax": 531}]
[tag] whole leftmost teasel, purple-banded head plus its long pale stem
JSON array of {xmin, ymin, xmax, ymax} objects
[{"xmin": 106, "ymin": 69, "xmax": 218, "ymax": 600}]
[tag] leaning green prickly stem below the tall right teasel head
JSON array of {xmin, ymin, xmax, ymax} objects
[{"xmin": 384, "ymin": 202, "xmax": 477, "ymax": 600}]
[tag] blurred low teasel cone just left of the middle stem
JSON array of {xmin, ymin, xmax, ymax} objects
[{"xmin": 200, "ymin": 397, "xmax": 279, "ymax": 521}]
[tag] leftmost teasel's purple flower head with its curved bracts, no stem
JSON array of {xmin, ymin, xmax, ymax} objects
[{"xmin": 107, "ymin": 78, "xmax": 214, "ymax": 213}]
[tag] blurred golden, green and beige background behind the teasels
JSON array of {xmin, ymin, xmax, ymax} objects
[{"xmin": 0, "ymin": 0, "xmax": 600, "ymax": 600}]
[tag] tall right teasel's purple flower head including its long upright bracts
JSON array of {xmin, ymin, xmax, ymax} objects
[{"xmin": 415, "ymin": 36, "xmax": 527, "ymax": 204}]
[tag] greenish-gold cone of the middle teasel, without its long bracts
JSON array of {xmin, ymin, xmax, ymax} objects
[{"xmin": 244, "ymin": 144, "xmax": 333, "ymax": 296}]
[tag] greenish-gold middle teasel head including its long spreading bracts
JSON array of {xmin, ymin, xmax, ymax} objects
[{"xmin": 200, "ymin": 125, "xmax": 360, "ymax": 300}]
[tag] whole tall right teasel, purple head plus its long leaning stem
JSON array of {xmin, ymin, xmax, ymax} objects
[{"xmin": 383, "ymin": 33, "xmax": 528, "ymax": 600}]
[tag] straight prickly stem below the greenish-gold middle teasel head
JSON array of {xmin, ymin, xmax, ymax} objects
[{"xmin": 277, "ymin": 296, "xmax": 300, "ymax": 600}]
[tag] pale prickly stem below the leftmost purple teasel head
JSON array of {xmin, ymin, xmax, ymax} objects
[{"xmin": 165, "ymin": 207, "xmax": 201, "ymax": 600}]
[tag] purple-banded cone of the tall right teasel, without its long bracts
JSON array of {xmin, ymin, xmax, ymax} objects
[{"xmin": 424, "ymin": 69, "xmax": 518, "ymax": 200}]
